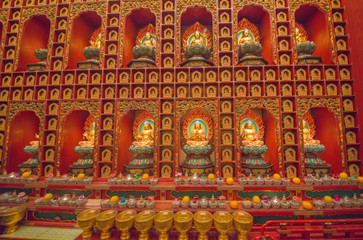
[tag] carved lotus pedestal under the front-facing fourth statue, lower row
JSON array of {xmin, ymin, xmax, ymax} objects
[{"xmin": 181, "ymin": 145, "xmax": 214, "ymax": 176}]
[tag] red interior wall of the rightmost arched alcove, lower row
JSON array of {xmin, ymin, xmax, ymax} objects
[{"xmin": 310, "ymin": 107, "xmax": 343, "ymax": 173}]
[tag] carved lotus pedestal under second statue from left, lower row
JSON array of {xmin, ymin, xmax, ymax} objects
[{"xmin": 69, "ymin": 146, "xmax": 93, "ymax": 176}]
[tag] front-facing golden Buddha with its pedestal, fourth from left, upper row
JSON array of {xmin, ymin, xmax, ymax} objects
[{"xmin": 182, "ymin": 22, "xmax": 213, "ymax": 67}]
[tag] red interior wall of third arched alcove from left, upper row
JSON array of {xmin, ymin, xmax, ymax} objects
[{"xmin": 122, "ymin": 8, "xmax": 157, "ymax": 67}]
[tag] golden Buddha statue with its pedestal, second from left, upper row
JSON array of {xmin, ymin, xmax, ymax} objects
[{"xmin": 77, "ymin": 28, "xmax": 102, "ymax": 69}]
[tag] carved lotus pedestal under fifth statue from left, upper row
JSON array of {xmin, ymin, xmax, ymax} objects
[{"xmin": 238, "ymin": 42, "xmax": 267, "ymax": 66}]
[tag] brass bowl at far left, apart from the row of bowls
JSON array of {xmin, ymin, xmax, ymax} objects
[{"xmin": 0, "ymin": 206, "xmax": 26, "ymax": 233}]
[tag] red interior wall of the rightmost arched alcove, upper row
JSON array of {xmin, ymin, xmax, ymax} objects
[{"xmin": 295, "ymin": 4, "xmax": 333, "ymax": 64}]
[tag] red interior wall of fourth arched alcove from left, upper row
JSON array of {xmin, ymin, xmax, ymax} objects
[{"xmin": 180, "ymin": 5, "xmax": 214, "ymax": 64}]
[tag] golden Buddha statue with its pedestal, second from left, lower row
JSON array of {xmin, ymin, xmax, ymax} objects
[{"xmin": 69, "ymin": 115, "xmax": 96, "ymax": 176}]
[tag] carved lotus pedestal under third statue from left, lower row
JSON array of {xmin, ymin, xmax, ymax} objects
[{"xmin": 125, "ymin": 145, "xmax": 154, "ymax": 176}]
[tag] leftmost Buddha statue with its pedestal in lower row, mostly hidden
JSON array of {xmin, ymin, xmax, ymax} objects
[{"xmin": 18, "ymin": 134, "xmax": 39, "ymax": 174}]
